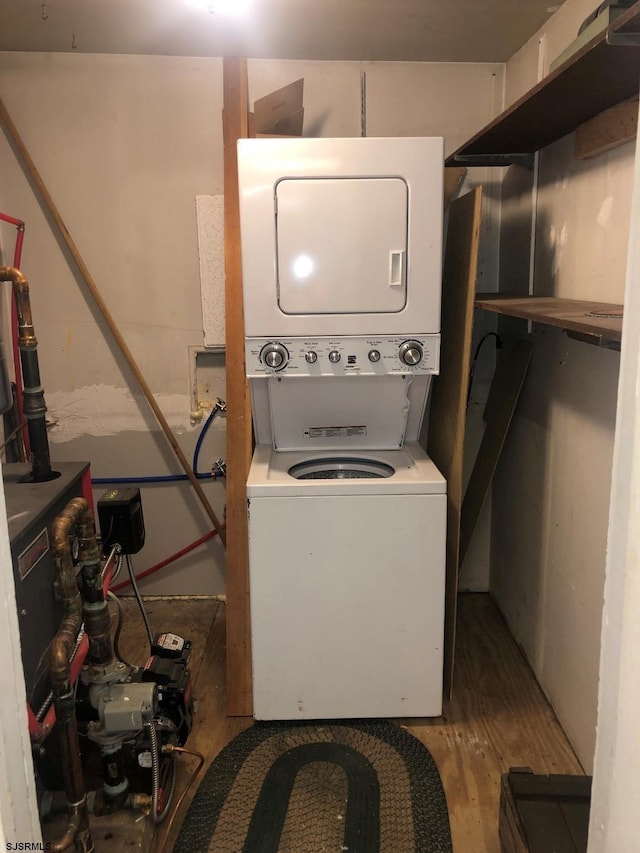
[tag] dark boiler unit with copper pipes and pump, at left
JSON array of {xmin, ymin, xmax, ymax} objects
[{"xmin": 0, "ymin": 267, "xmax": 193, "ymax": 850}]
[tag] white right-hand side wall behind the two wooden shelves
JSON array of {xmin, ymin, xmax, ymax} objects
[{"xmin": 491, "ymin": 0, "xmax": 634, "ymax": 772}]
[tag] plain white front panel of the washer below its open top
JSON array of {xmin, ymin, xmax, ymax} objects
[{"xmin": 249, "ymin": 493, "xmax": 446, "ymax": 720}]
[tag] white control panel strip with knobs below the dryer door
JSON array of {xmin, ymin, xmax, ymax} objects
[{"xmin": 245, "ymin": 335, "xmax": 440, "ymax": 377}]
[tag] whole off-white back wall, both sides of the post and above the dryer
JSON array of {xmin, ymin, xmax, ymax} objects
[{"xmin": 0, "ymin": 52, "xmax": 504, "ymax": 595}]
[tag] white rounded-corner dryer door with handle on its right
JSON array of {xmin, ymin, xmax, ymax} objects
[{"xmin": 275, "ymin": 178, "xmax": 409, "ymax": 314}]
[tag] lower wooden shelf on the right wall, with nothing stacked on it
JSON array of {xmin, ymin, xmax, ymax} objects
[{"xmin": 474, "ymin": 293, "xmax": 623, "ymax": 349}]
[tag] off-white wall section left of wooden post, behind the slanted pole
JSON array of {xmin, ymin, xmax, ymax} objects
[{"xmin": 0, "ymin": 53, "xmax": 230, "ymax": 593}]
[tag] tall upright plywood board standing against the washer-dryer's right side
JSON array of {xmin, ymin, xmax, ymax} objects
[{"xmin": 427, "ymin": 187, "xmax": 482, "ymax": 694}]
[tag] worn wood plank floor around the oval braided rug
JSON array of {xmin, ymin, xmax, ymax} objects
[{"xmin": 106, "ymin": 594, "xmax": 583, "ymax": 853}]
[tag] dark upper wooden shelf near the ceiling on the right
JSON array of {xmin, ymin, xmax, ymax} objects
[{"xmin": 446, "ymin": 2, "xmax": 640, "ymax": 166}]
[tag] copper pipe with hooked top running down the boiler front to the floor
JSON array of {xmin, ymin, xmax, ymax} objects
[{"xmin": 49, "ymin": 498, "xmax": 97, "ymax": 853}]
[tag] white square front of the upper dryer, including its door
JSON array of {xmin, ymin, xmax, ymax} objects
[{"xmin": 238, "ymin": 137, "xmax": 444, "ymax": 338}]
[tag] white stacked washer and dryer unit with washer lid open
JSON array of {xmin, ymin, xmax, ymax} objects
[{"xmin": 238, "ymin": 138, "xmax": 446, "ymax": 720}]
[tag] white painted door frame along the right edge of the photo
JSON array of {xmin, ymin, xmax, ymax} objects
[{"xmin": 589, "ymin": 110, "xmax": 640, "ymax": 853}]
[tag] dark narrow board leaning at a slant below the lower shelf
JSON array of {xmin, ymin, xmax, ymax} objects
[{"xmin": 460, "ymin": 337, "xmax": 533, "ymax": 562}]
